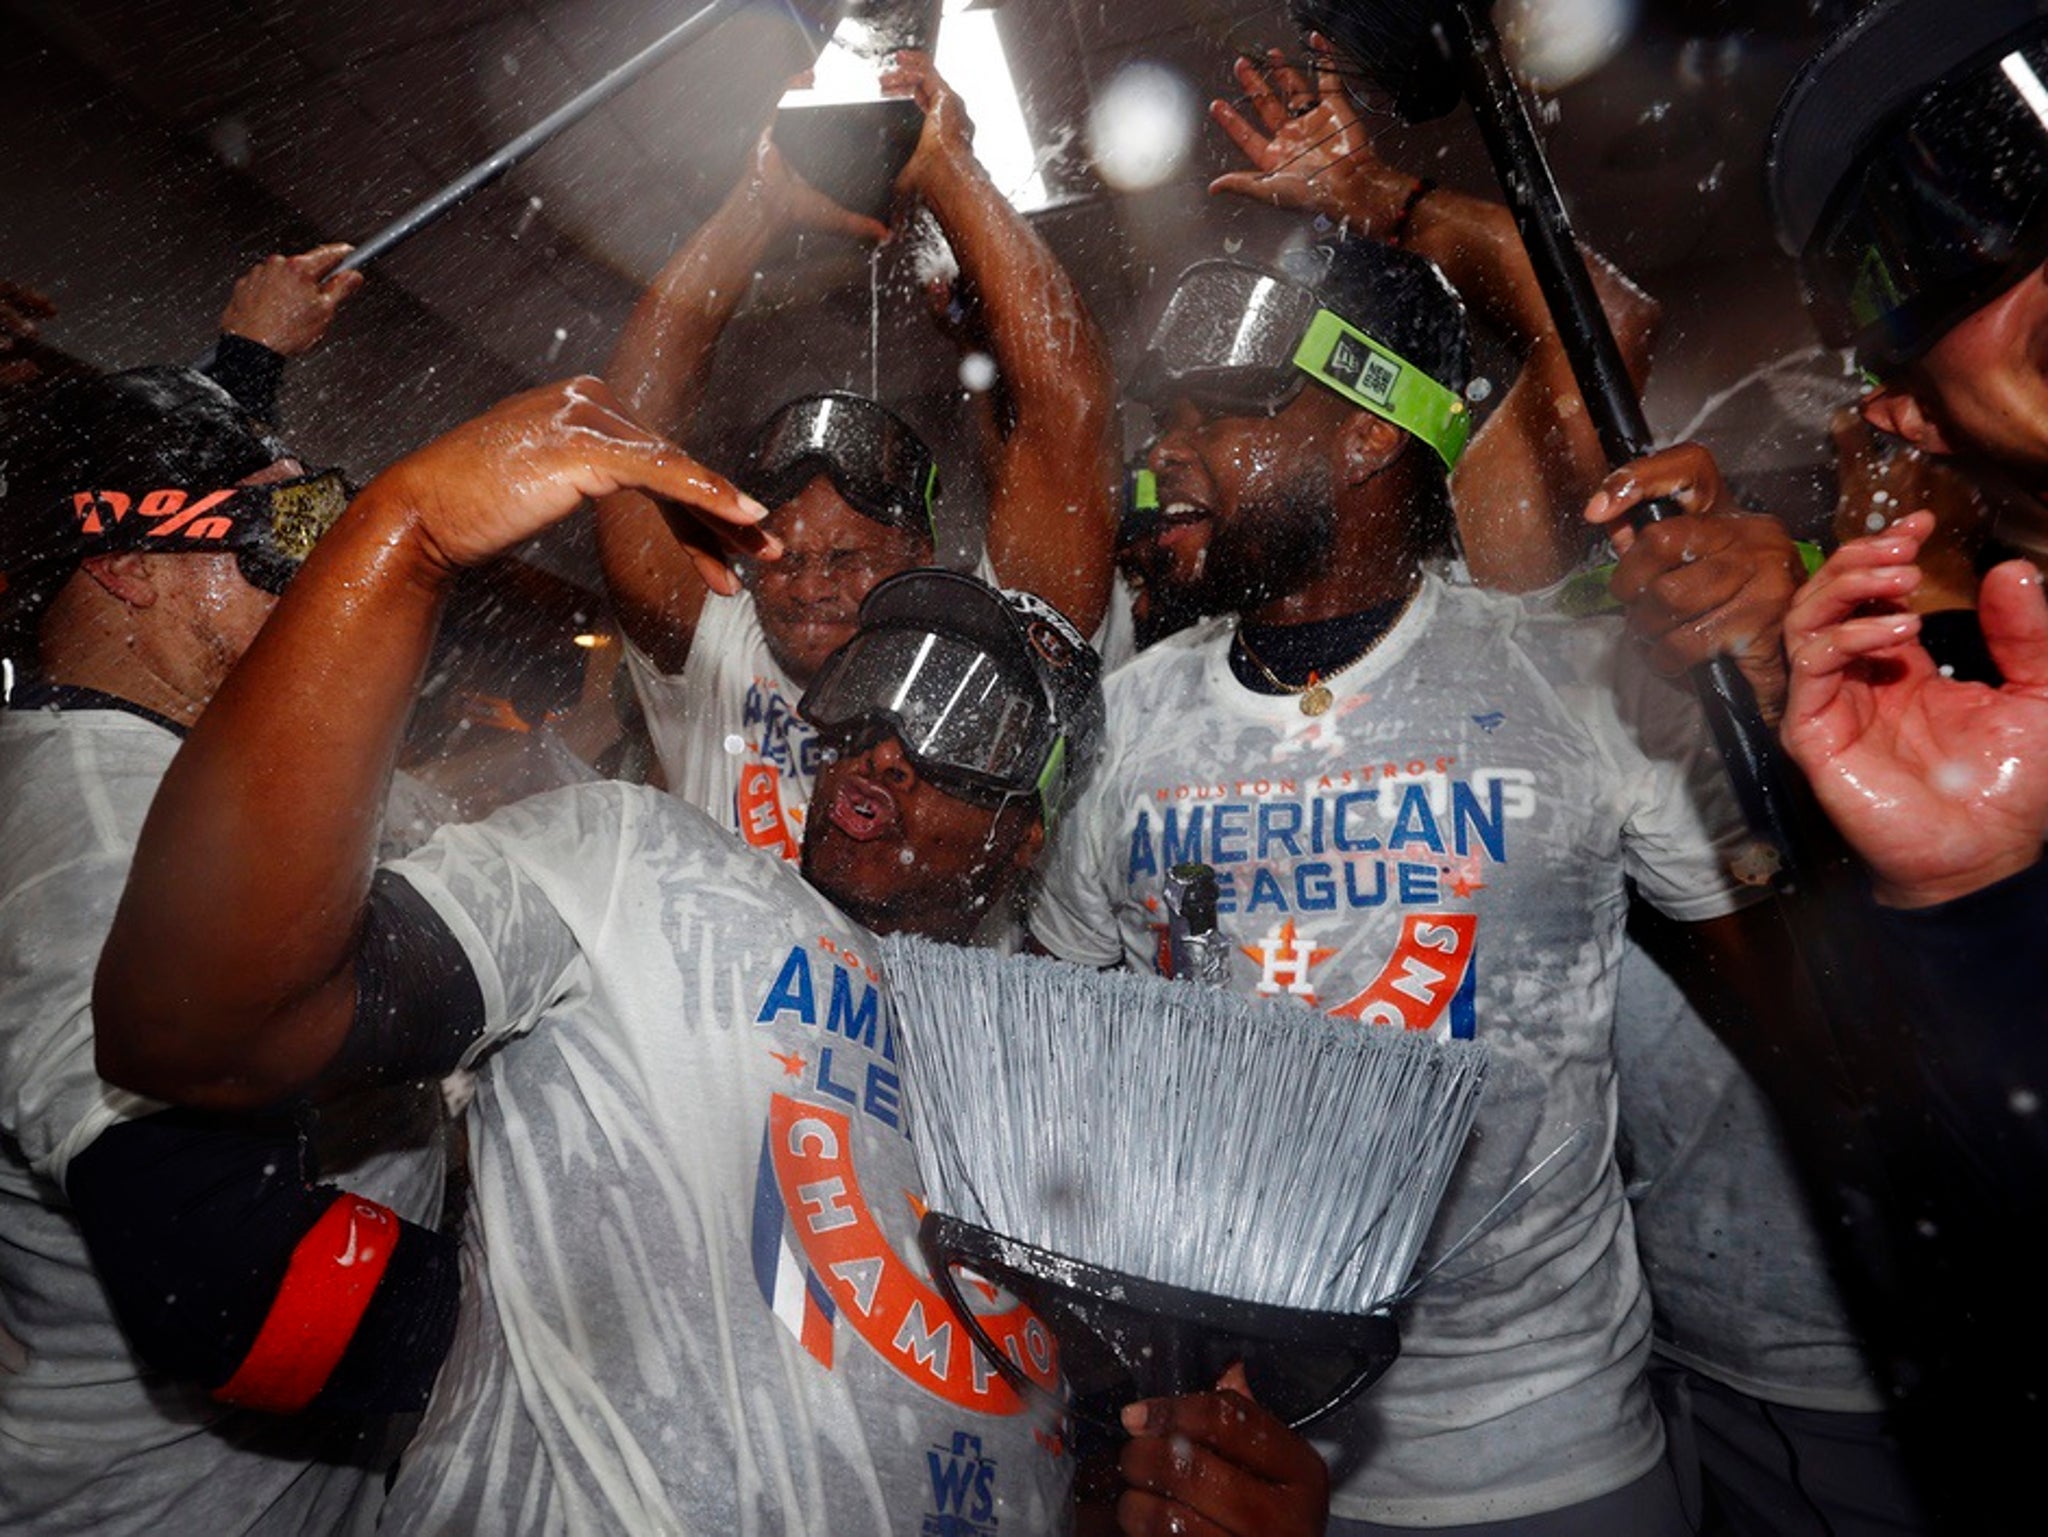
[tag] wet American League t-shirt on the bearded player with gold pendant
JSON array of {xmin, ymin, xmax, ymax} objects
[{"xmin": 1030, "ymin": 578, "xmax": 1739, "ymax": 1525}]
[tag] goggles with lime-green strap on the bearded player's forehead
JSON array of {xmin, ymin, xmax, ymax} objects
[{"xmin": 1133, "ymin": 262, "xmax": 1473, "ymax": 469}]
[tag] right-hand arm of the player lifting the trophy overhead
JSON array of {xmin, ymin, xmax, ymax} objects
[{"xmin": 883, "ymin": 53, "xmax": 1120, "ymax": 633}]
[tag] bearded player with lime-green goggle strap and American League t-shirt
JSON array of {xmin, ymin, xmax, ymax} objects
[{"xmin": 1030, "ymin": 240, "xmax": 1794, "ymax": 1533}]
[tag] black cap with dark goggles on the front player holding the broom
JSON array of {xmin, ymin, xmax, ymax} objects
[{"xmin": 799, "ymin": 568, "xmax": 1102, "ymax": 824}]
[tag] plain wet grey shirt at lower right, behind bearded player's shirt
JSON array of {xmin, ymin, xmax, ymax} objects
[{"xmin": 1614, "ymin": 945, "xmax": 1884, "ymax": 1414}]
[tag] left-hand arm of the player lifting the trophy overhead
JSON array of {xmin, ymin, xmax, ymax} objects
[{"xmin": 598, "ymin": 133, "xmax": 889, "ymax": 672}]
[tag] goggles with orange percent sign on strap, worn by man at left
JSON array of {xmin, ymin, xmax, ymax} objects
[{"xmin": 72, "ymin": 469, "xmax": 348, "ymax": 592}]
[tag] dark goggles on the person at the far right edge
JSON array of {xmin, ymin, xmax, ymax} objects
[{"xmin": 1800, "ymin": 39, "xmax": 2048, "ymax": 369}]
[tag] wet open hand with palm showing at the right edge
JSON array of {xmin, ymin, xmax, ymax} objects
[{"xmin": 1784, "ymin": 512, "xmax": 2048, "ymax": 908}]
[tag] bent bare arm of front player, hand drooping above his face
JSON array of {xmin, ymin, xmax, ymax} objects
[{"xmin": 92, "ymin": 379, "xmax": 778, "ymax": 1109}]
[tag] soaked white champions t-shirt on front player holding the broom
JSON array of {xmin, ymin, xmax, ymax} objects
[{"xmin": 385, "ymin": 783, "xmax": 1067, "ymax": 1537}]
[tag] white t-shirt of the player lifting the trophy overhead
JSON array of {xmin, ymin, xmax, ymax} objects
[{"xmin": 625, "ymin": 555, "xmax": 1130, "ymax": 861}]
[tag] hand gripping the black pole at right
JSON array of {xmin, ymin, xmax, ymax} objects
[{"xmin": 1585, "ymin": 443, "xmax": 1806, "ymax": 721}]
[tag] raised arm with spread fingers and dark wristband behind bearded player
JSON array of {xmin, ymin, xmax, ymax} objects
[{"xmin": 1210, "ymin": 39, "xmax": 1657, "ymax": 592}]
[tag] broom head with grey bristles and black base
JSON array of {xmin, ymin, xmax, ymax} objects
[{"xmin": 887, "ymin": 939, "xmax": 1487, "ymax": 1430}]
